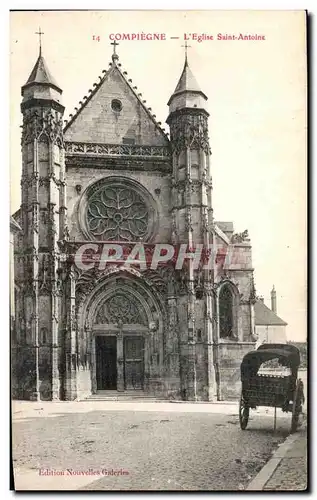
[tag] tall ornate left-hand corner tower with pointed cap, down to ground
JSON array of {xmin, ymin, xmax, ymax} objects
[{"xmin": 16, "ymin": 47, "xmax": 66, "ymax": 400}]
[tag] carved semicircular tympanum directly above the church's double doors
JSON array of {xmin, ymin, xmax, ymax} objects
[{"xmin": 95, "ymin": 293, "xmax": 146, "ymax": 325}]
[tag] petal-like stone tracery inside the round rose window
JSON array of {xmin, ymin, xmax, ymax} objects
[{"xmin": 87, "ymin": 184, "xmax": 149, "ymax": 241}]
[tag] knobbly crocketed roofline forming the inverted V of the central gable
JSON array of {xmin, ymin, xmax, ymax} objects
[{"xmin": 64, "ymin": 62, "xmax": 169, "ymax": 141}]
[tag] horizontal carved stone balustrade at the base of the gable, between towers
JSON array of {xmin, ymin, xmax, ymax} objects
[{"xmin": 65, "ymin": 142, "xmax": 171, "ymax": 158}]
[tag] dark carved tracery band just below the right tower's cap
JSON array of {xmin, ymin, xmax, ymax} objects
[{"xmin": 170, "ymin": 113, "xmax": 211, "ymax": 154}]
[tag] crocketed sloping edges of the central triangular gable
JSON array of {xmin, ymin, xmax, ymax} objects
[{"xmin": 64, "ymin": 54, "xmax": 169, "ymax": 143}]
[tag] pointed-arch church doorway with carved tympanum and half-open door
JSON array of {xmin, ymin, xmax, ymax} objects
[{"xmin": 83, "ymin": 272, "xmax": 164, "ymax": 393}]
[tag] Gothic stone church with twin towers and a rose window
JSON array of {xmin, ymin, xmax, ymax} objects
[{"xmin": 11, "ymin": 45, "xmax": 256, "ymax": 401}]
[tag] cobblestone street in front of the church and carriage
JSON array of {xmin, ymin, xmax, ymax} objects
[{"xmin": 13, "ymin": 402, "xmax": 290, "ymax": 490}]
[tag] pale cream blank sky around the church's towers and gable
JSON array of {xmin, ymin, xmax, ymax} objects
[{"xmin": 10, "ymin": 11, "xmax": 307, "ymax": 341}]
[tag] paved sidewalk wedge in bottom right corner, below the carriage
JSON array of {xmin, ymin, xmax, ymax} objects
[{"xmin": 247, "ymin": 428, "xmax": 307, "ymax": 491}]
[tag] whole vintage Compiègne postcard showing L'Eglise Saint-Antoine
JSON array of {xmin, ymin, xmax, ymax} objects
[{"xmin": 10, "ymin": 10, "xmax": 307, "ymax": 491}]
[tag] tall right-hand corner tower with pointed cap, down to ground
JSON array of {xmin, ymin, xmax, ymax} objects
[{"xmin": 166, "ymin": 54, "xmax": 215, "ymax": 400}]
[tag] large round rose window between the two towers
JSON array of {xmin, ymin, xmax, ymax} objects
[{"xmin": 84, "ymin": 178, "xmax": 154, "ymax": 241}]
